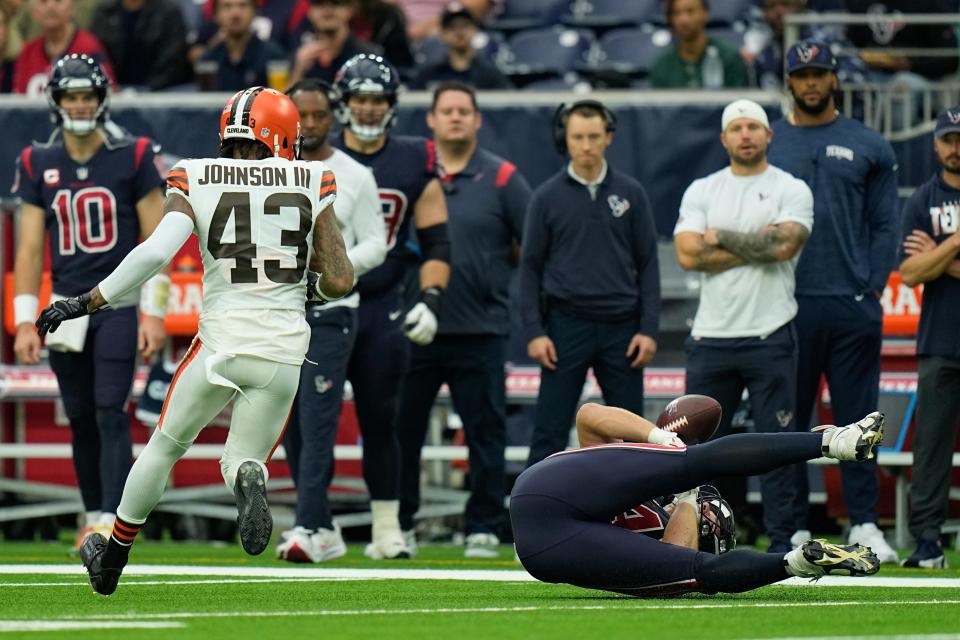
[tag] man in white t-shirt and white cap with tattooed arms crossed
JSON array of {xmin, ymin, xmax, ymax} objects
[{"xmin": 673, "ymin": 100, "xmax": 813, "ymax": 552}]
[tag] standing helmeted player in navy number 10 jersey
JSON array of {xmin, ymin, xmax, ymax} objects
[{"xmin": 12, "ymin": 54, "xmax": 169, "ymax": 546}]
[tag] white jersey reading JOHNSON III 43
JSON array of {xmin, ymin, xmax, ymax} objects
[{"xmin": 167, "ymin": 158, "xmax": 337, "ymax": 364}]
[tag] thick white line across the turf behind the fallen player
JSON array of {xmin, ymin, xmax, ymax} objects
[{"xmin": 0, "ymin": 564, "xmax": 960, "ymax": 589}]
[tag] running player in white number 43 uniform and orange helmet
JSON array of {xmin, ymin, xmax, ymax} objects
[{"xmin": 37, "ymin": 87, "xmax": 354, "ymax": 595}]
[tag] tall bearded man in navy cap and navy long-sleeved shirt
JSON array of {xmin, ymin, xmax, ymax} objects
[{"xmin": 769, "ymin": 42, "xmax": 899, "ymax": 562}]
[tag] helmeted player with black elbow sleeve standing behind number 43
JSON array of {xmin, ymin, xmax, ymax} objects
[{"xmin": 336, "ymin": 54, "xmax": 450, "ymax": 558}]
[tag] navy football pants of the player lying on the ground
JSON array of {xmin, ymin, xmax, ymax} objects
[{"xmin": 510, "ymin": 433, "xmax": 822, "ymax": 595}]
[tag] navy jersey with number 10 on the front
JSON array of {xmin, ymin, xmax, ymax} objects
[{"xmin": 12, "ymin": 137, "xmax": 163, "ymax": 296}]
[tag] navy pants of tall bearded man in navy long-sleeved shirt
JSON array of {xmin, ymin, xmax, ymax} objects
[{"xmin": 794, "ymin": 294, "xmax": 883, "ymax": 529}]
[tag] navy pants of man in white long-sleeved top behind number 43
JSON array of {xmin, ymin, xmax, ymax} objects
[{"xmin": 283, "ymin": 305, "xmax": 357, "ymax": 529}]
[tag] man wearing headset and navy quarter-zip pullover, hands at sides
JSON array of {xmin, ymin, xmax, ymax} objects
[{"xmin": 520, "ymin": 100, "xmax": 660, "ymax": 466}]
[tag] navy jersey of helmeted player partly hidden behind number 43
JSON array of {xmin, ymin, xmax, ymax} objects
[{"xmin": 334, "ymin": 134, "xmax": 438, "ymax": 297}]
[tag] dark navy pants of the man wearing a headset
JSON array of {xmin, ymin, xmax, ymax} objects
[{"xmin": 527, "ymin": 310, "xmax": 643, "ymax": 467}]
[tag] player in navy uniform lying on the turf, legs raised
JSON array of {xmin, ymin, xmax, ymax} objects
[{"xmin": 510, "ymin": 404, "xmax": 883, "ymax": 596}]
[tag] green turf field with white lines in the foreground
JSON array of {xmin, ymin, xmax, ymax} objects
[{"xmin": 0, "ymin": 541, "xmax": 960, "ymax": 640}]
